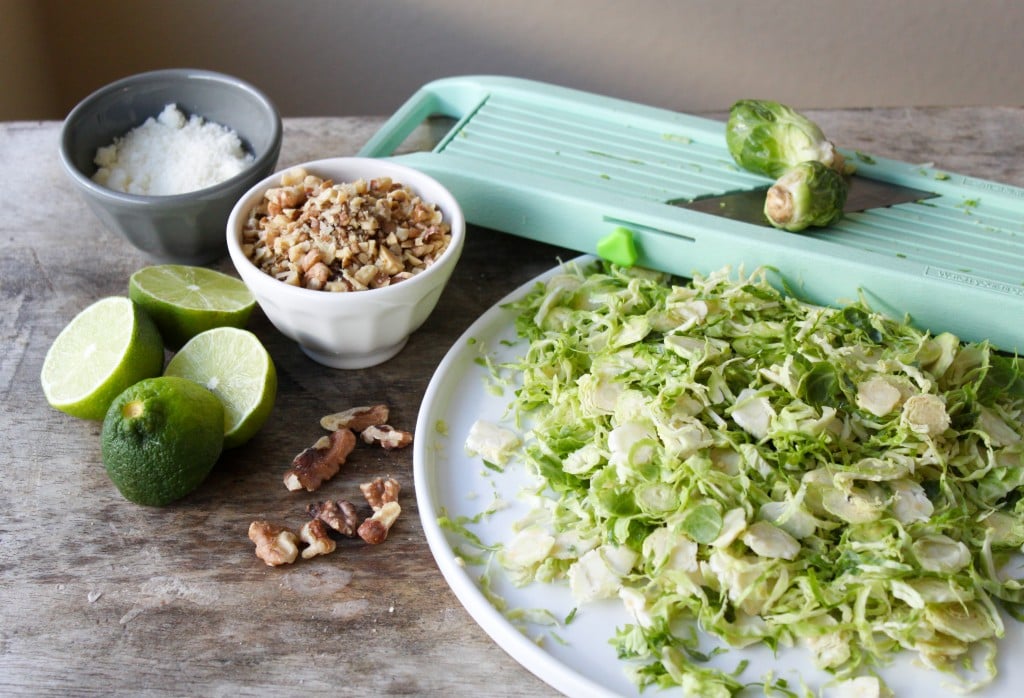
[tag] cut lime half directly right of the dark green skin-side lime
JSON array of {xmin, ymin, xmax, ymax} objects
[{"xmin": 164, "ymin": 328, "xmax": 278, "ymax": 448}]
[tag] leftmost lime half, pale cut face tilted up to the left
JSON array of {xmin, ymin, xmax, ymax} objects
[{"xmin": 40, "ymin": 297, "xmax": 164, "ymax": 420}]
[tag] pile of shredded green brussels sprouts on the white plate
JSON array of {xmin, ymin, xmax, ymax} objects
[{"xmin": 462, "ymin": 257, "xmax": 1024, "ymax": 696}]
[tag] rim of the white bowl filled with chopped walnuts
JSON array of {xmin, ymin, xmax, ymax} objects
[{"xmin": 225, "ymin": 156, "xmax": 466, "ymax": 304}]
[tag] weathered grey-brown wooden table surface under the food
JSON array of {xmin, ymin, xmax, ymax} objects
[{"xmin": 0, "ymin": 107, "xmax": 1024, "ymax": 696}]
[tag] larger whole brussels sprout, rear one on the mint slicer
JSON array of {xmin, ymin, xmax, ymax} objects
[{"xmin": 725, "ymin": 99, "xmax": 852, "ymax": 179}]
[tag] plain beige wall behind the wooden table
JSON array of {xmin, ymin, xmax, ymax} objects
[{"xmin": 0, "ymin": 0, "xmax": 1024, "ymax": 120}]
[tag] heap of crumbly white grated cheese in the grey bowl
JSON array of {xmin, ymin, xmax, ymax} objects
[{"xmin": 92, "ymin": 104, "xmax": 253, "ymax": 197}]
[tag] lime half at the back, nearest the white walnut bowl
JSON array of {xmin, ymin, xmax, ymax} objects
[{"xmin": 128, "ymin": 264, "xmax": 256, "ymax": 349}]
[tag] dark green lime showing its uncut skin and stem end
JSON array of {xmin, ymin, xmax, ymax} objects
[{"xmin": 100, "ymin": 376, "xmax": 224, "ymax": 507}]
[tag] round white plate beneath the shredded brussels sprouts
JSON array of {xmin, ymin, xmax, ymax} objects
[{"xmin": 413, "ymin": 257, "xmax": 1024, "ymax": 698}]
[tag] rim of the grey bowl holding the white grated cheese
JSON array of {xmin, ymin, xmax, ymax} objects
[{"xmin": 58, "ymin": 68, "xmax": 284, "ymax": 206}]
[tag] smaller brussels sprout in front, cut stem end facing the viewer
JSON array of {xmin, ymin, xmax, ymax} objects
[{"xmin": 765, "ymin": 160, "xmax": 848, "ymax": 232}]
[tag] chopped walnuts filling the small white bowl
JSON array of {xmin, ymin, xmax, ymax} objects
[{"xmin": 242, "ymin": 168, "xmax": 452, "ymax": 292}]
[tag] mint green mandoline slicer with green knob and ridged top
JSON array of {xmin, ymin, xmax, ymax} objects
[{"xmin": 359, "ymin": 76, "xmax": 1024, "ymax": 353}]
